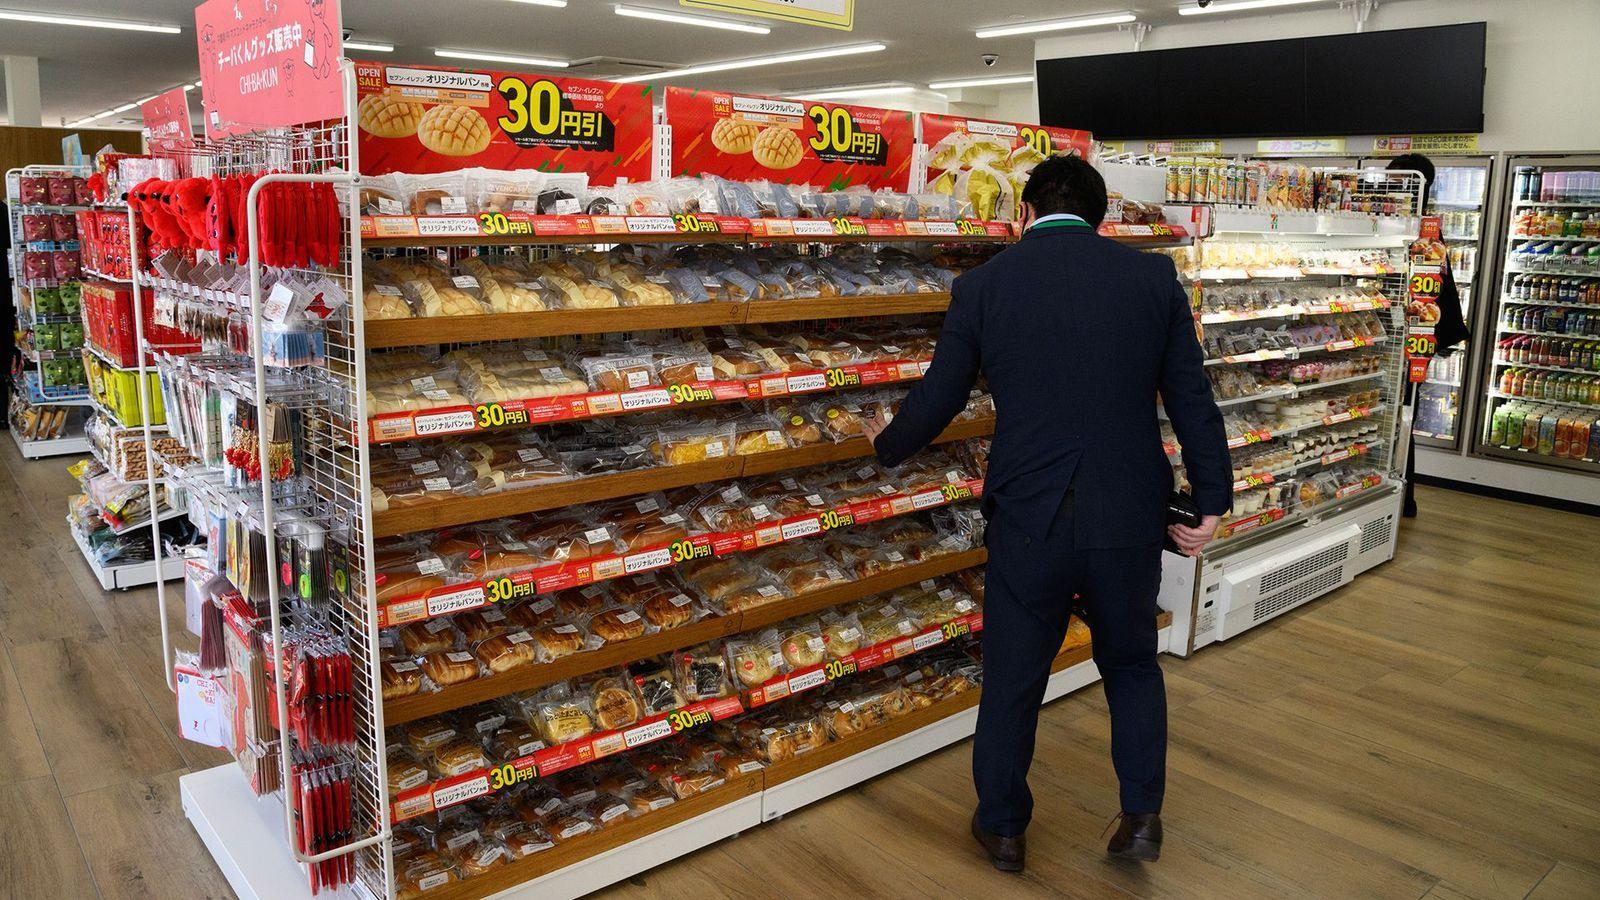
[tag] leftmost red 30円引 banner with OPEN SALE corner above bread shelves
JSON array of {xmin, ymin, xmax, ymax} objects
[{"xmin": 355, "ymin": 62, "xmax": 654, "ymax": 184}]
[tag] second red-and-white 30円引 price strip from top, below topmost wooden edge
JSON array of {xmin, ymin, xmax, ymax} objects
[{"xmin": 368, "ymin": 360, "xmax": 925, "ymax": 444}]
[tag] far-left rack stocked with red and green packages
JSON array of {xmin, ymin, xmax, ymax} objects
[{"xmin": 5, "ymin": 165, "xmax": 90, "ymax": 460}]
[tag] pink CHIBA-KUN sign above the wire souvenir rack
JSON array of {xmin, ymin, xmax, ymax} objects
[{"xmin": 195, "ymin": 0, "xmax": 344, "ymax": 138}]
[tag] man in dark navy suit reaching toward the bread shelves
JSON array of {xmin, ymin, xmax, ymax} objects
[{"xmin": 867, "ymin": 157, "xmax": 1234, "ymax": 871}]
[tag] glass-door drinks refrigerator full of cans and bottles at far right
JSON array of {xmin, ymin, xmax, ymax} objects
[{"xmin": 1475, "ymin": 155, "xmax": 1600, "ymax": 474}]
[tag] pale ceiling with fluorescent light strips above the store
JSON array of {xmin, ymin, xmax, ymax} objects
[{"xmin": 0, "ymin": 0, "xmax": 1209, "ymax": 127}]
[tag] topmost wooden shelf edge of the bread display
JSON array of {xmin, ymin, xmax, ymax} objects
[{"xmin": 366, "ymin": 291, "xmax": 950, "ymax": 349}]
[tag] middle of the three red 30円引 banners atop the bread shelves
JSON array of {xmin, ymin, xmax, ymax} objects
[{"xmin": 667, "ymin": 88, "xmax": 917, "ymax": 191}]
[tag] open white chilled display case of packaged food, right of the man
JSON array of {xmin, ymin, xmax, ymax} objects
[{"xmin": 1162, "ymin": 168, "xmax": 1422, "ymax": 652}]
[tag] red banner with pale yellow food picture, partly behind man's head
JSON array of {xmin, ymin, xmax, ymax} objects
[{"xmin": 918, "ymin": 112, "xmax": 1094, "ymax": 219}]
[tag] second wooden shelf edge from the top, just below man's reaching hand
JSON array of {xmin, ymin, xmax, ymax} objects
[{"xmin": 373, "ymin": 418, "xmax": 994, "ymax": 538}]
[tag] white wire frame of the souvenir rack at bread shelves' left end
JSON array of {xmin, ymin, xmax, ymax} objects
[{"xmin": 128, "ymin": 61, "xmax": 394, "ymax": 897}]
